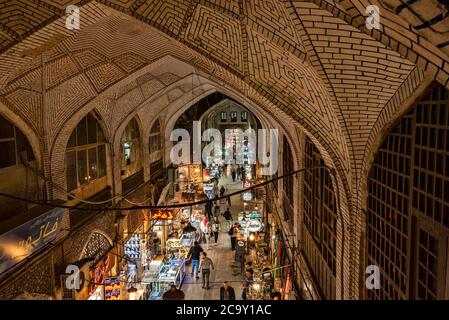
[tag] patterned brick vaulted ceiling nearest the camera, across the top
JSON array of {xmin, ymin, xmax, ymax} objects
[{"xmin": 0, "ymin": 0, "xmax": 449, "ymax": 200}]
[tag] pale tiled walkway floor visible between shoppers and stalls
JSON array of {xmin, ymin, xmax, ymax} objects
[{"xmin": 181, "ymin": 177, "xmax": 243, "ymax": 300}]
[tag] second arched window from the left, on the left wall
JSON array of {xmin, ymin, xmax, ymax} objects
[{"xmin": 65, "ymin": 113, "xmax": 106, "ymax": 191}]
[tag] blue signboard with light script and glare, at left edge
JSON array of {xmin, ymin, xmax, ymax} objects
[{"xmin": 0, "ymin": 208, "xmax": 64, "ymax": 274}]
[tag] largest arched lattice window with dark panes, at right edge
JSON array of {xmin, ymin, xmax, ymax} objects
[{"xmin": 365, "ymin": 84, "xmax": 449, "ymax": 300}]
